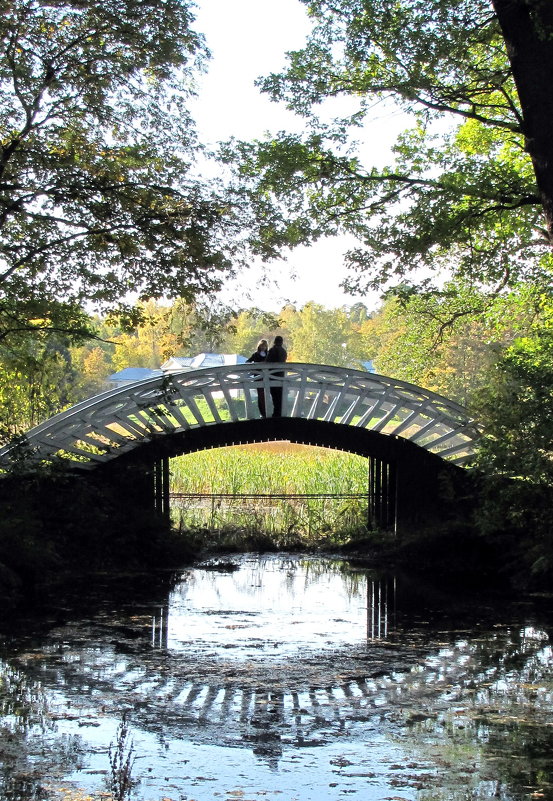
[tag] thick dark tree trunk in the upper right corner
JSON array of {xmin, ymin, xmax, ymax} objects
[{"xmin": 492, "ymin": 0, "xmax": 553, "ymax": 247}]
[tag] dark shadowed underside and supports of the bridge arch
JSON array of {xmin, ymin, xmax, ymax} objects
[{"xmin": 101, "ymin": 418, "xmax": 467, "ymax": 531}]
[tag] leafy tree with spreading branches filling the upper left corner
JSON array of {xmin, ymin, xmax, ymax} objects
[{"xmin": 0, "ymin": 0, "xmax": 243, "ymax": 334}]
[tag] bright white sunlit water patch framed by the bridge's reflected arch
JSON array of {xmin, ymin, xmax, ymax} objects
[{"xmin": 157, "ymin": 558, "xmax": 378, "ymax": 660}]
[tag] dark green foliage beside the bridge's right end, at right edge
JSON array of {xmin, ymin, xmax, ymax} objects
[{"xmin": 477, "ymin": 318, "xmax": 553, "ymax": 577}]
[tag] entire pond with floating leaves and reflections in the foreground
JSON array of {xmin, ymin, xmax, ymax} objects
[{"xmin": 0, "ymin": 554, "xmax": 553, "ymax": 801}]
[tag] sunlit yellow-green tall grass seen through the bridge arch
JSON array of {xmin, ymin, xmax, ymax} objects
[{"xmin": 171, "ymin": 442, "xmax": 367, "ymax": 547}]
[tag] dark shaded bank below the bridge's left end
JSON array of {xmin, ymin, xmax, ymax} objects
[{"xmin": 0, "ymin": 472, "xmax": 194, "ymax": 611}]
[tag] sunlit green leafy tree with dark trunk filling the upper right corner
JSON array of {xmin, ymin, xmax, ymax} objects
[{"xmin": 222, "ymin": 0, "xmax": 553, "ymax": 292}]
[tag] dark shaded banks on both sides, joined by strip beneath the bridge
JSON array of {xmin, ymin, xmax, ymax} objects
[{"xmin": 0, "ymin": 462, "xmax": 553, "ymax": 612}]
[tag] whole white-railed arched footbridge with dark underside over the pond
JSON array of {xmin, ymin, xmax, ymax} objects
[{"xmin": 0, "ymin": 363, "xmax": 480, "ymax": 522}]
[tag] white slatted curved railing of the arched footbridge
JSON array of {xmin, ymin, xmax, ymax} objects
[{"xmin": 0, "ymin": 363, "xmax": 480, "ymax": 469}]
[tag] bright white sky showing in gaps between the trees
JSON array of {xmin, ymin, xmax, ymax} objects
[{"xmin": 190, "ymin": 0, "xmax": 406, "ymax": 311}]
